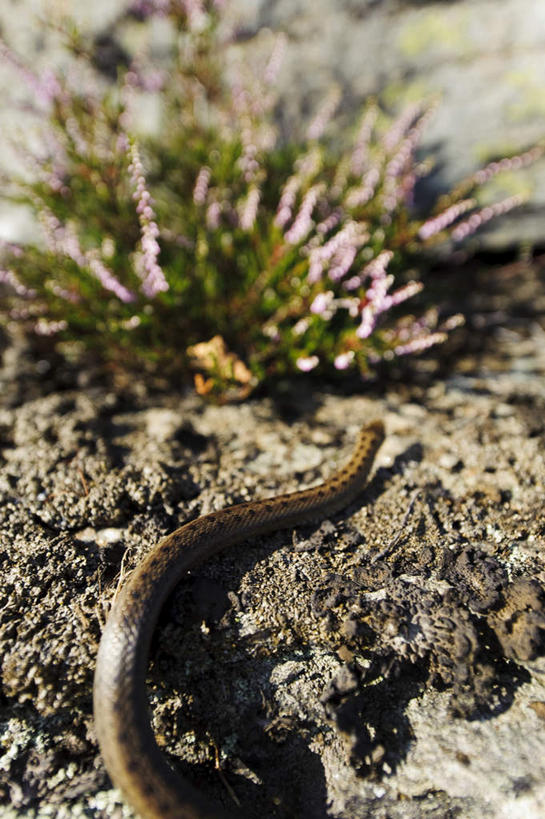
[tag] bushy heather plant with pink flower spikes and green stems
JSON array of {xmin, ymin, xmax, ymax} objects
[{"xmin": 0, "ymin": 0, "xmax": 542, "ymax": 397}]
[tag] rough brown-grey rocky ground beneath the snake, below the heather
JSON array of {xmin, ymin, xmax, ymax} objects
[{"xmin": 0, "ymin": 253, "xmax": 545, "ymax": 819}]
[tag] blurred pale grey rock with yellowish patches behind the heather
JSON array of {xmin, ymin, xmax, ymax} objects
[{"xmin": 0, "ymin": 0, "xmax": 545, "ymax": 250}]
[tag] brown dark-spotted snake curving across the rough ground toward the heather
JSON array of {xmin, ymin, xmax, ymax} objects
[{"xmin": 94, "ymin": 421, "xmax": 384, "ymax": 819}]
